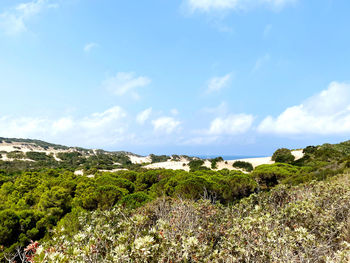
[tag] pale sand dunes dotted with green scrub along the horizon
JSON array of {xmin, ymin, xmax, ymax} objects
[{"xmin": 0, "ymin": 137, "xmax": 303, "ymax": 175}]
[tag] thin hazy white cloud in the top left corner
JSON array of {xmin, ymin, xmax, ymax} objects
[{"xmin": 0, "ymin": 0, "xmax": 58, "ymax": 35}]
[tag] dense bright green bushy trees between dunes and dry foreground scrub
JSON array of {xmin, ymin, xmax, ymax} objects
[{"xmin": 0, "ymin": 169, "xmax": 257, "ymax": 258}]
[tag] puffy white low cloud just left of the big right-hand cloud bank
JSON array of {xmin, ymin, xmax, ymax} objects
[{"xmin": 208, "ymin": 113, "xmax": 254, "ymax": 135}]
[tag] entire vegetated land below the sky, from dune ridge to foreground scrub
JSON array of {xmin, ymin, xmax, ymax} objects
[{"xmin": 0, "ymin": 139, "xmax": 350, "ymax": 262}]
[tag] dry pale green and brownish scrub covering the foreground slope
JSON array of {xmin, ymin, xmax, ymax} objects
[{"xmin": 34, "ymin": 176, "xmax": 350, "ymax": 263}]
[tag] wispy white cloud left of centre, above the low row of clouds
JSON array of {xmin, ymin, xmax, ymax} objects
[{"xmin": 102, "ymin": 72, "xmax": 151, "ymax": 99}]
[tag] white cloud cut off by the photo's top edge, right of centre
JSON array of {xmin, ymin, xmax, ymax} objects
[{"xmin": 184, "ymin": 0, "xmax": 297, "ymax": 12}]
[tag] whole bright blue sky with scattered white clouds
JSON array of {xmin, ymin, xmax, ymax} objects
[{"xmin": 0, "ymin": 0, "xmax": 350, "ymax": 155}]
